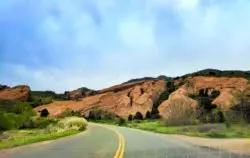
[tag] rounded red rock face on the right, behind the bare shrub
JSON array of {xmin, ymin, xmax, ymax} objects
[{"xmin": 158, "ymin": 76, "xmax": 250, "ymax": 115}]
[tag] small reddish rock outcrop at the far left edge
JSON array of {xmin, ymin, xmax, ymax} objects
[{"xmin": 0, "ymin": 85, "xmax": 30, "ymax": 101}]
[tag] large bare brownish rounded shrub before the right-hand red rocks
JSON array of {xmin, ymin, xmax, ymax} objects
[{"xmin": 163, "ymin": 99, "xmax": 195, "ymax": 126}]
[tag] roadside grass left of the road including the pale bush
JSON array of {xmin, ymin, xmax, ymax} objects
[{"xmin": 0, "ymin": 117, "xmax": 88, "ymax": 149}]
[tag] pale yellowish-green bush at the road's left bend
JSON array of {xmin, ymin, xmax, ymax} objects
[{"xmin": 45, "ymin": 116, "xmax": 88, "ymax": 133}]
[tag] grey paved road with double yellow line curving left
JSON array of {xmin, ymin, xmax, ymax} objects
[{"xmin": 0, "ymin": 124, "xmax": 249, "ymax": 158}]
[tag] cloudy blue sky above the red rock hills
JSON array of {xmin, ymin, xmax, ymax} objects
[{"xmin": 0, "ymin": 0, "xmax": 250, "ymax": 92}]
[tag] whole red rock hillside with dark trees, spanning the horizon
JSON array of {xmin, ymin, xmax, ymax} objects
[{"xmin": 0, "ymin": 69, "xmax": 250, "ymax": 117}]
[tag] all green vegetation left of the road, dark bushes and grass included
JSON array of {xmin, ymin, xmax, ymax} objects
[{"xmin": 0, "ymin": 100, "xmax": 87, "ymax": 149}]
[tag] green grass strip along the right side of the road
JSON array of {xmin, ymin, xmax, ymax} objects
[{"xmin": 92, "ymin": 120, "xmax": 250, "ymax": 138}]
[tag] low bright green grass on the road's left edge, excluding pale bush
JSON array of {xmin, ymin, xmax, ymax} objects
[{"xmin": 0, "ymin": 129, "xmax": 80, "ymax": 149}]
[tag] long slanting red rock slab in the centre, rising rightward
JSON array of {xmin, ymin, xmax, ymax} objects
[{"xmin": 36, "ymin": 80, "xmax": 166, "ymax": 117}]
